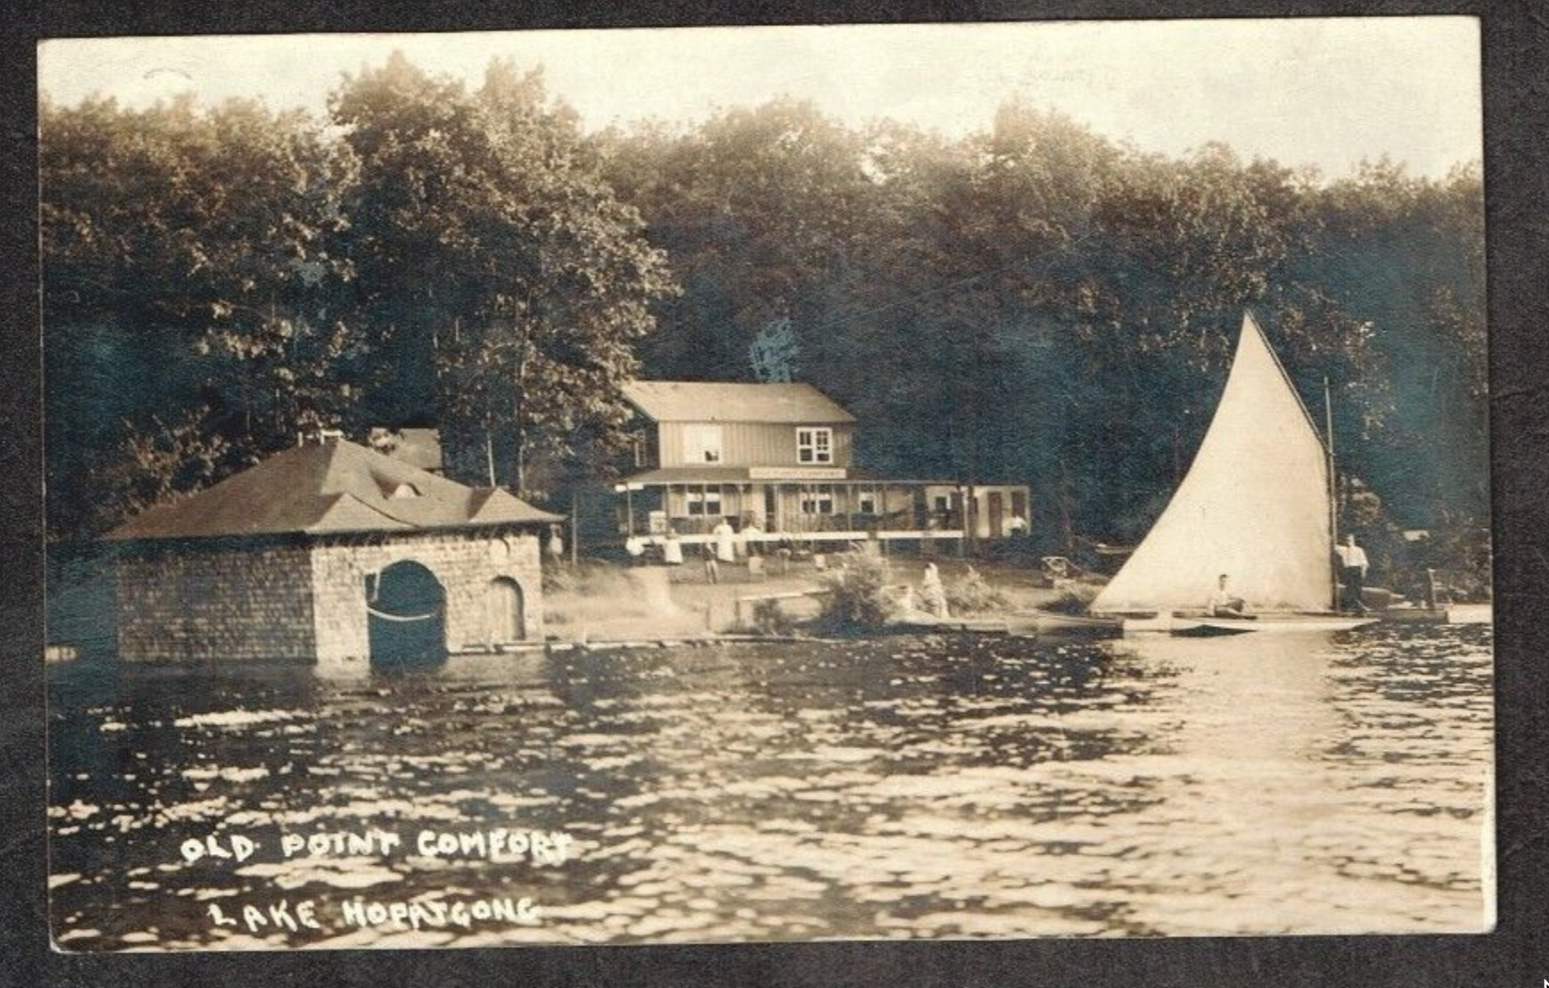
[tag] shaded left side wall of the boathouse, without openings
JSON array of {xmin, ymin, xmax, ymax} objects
[{"xmin": 115, "ymin": 544, "xmax": 316, "ymax": 661}]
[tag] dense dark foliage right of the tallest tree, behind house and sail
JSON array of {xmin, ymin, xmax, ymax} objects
[{"xmin": 601, "ymin": 102, "xmax": 1487, "ymax": 548}]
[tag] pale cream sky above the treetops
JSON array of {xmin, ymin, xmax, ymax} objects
[{"xmin": 39, "ymin": 17, "xmax": 1482, "ymax": 178}]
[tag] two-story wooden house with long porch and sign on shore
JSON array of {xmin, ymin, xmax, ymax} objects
[{"xmin": 617, "ymin": 381, "xmax": 1030, "ymax": 542}]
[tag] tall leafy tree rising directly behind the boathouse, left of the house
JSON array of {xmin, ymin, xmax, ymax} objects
[{"xmin": 330, "ymin": 54, "xmax": 675, "ymax": 492}]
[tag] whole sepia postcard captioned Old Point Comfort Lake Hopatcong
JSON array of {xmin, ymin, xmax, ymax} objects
[{"xmin": 39, "ymin": 17, "xmax": 1495, "ymax": 952}]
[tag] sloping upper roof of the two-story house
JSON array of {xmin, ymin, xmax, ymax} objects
[{"xmin": 624, "ymin": 381, "xmax": 855, "ymax": 424}]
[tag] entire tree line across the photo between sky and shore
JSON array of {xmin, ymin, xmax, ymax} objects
[{"xmin": 40, "ymin": 56, "xmax": 1489, "ymax": 572}]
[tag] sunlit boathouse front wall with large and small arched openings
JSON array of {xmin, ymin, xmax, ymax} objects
[{"xmin": 311, "ymin": 531, "xmax": 544, "ymax": 678}]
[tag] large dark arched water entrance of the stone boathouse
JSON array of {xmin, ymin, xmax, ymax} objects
[{"xmin": 366, "ymin": 561, "xmax": 446, "ymax": 671}]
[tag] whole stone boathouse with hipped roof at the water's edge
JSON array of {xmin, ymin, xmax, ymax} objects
[{"xmin": 107, "ymin": 434, "xmax": 562, "ymax": 666}]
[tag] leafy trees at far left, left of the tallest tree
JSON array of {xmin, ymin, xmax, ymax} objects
[{"xmin": 40, "ymin": 98, "xmax": 362, "ymax": 534}]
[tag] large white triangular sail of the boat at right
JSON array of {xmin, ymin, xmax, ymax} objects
[{"xmin": 1092, "ymin": 316, "xmax": 1334, "ymax": 613}]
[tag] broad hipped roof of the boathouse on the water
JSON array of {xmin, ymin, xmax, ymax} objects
[{"xmin": 107, "ymin": 440, "xmax": 562, "ymax": 540}]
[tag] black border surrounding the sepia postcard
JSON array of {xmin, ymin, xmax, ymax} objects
[{"xmin": 0, "ymin": 0, "xmax": 1549, "ymax": 988}]
